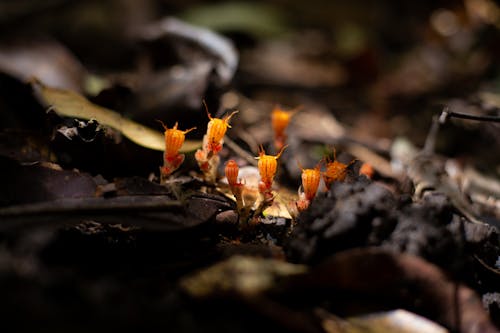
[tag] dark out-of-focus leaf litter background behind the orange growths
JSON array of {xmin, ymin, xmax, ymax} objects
[{"xmin": 0, "ymin": 0, "xmax": 500, "ymax": 173}]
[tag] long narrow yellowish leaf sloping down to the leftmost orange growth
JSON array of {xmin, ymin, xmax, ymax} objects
[{"xmin": 33, "ymin": 81, "xmax": 201, "ymax": 152}]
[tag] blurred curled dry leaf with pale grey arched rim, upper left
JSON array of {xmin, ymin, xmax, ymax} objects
[{"xmin": 133, "ymin": 17, "xmax": 238, "ymax": 112}]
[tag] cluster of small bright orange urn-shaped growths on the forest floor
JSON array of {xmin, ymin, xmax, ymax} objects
[{"xmin": 160, "ymin": 104, "xmax": 360, "ymax": 223}]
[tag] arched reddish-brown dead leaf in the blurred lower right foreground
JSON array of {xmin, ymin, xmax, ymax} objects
[{"xmin": 293, "ymin": 248, "xmax": 498, "ymax": 333}]
